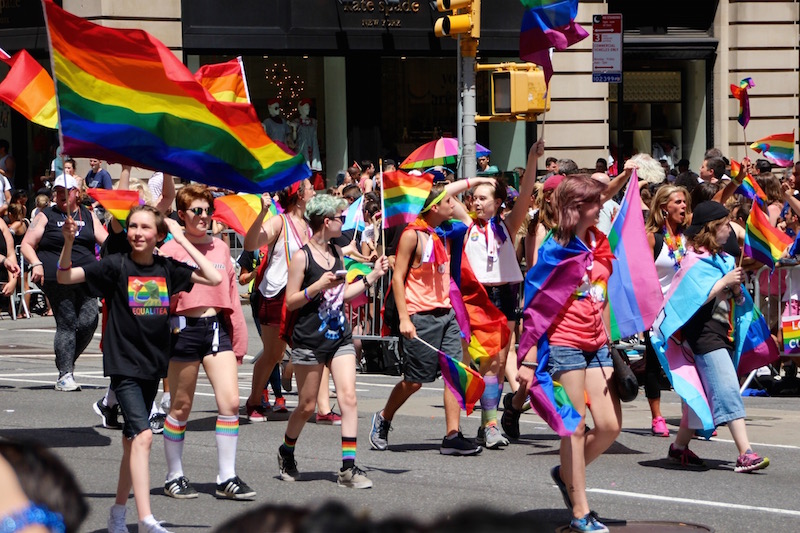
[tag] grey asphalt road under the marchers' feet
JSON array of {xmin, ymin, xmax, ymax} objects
[{"xmin": 0, "ymin": 317, "xmax": 800, "ymax": 532}]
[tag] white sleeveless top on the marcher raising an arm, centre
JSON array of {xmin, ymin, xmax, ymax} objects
[{"xmin": 464, "ymin": 217, "xmax": 522, "ymax": 285}]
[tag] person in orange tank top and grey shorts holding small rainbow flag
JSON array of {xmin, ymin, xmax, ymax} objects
[{"xmin": 369, "ymin": 184, "xmax": 482, "ymax": 455}]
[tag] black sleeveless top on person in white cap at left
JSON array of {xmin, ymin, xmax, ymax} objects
[{"xmin": 36, "ymin": 205, "xmax": 97, "ymax": 281}]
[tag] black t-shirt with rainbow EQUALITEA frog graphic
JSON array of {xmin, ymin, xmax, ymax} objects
[{"xmin": 84, "ymin": 254, "xmax": 194, "ymax": 379}]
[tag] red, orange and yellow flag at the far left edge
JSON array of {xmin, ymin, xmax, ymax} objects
[{"xmin": 0, "ymin": 49, "xmax": 58, "ymax": 129}]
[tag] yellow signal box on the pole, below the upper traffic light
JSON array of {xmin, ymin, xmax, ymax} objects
[{"xmin": 490, "ymin": 67, "xmax": 550, "ymax": 115}]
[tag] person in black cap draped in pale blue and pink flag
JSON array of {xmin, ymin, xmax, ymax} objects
[{"xmin": 651, "ymin": 201, "xmax": 773, "ymax": 472}]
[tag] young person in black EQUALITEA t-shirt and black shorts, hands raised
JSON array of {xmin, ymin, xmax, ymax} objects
[{"xmin": 57, "ymin": 205, "xmax": 222, "ymax": 533}]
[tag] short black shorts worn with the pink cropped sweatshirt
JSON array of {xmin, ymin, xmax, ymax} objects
[{"xmin": 170, "ymin": 314, "xmax": 233, "ymax": 362}]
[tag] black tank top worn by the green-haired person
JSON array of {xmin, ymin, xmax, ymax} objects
[{"xmin": 292, "ymin": 243, "xmax": 353, "ymax": 358}]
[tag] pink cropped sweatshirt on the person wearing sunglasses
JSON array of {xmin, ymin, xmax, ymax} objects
[{"xmin": 159, "ymin": 237, "xmax": 247, "ymax": 360}]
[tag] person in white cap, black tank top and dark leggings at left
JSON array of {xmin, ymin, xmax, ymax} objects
[{"xmin": 20, "ymin": 174, "xmax": 108, "ymax": 391}]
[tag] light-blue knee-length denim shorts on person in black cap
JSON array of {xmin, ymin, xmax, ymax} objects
[{"xmin": 694, "ymin": 348, "xmax": 745, "ymax": 426}]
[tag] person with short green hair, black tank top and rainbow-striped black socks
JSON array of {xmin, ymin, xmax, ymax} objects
[{"xmin": 278, "ymin": 194, "xmax": 389, "ymax": 489}]
